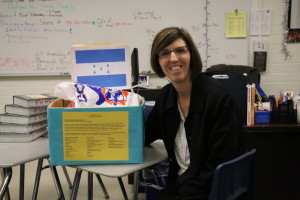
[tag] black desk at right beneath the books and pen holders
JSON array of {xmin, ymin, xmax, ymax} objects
[{"xmin": 244, "ymin": 124, "xmax": 300, "ymax": 200}]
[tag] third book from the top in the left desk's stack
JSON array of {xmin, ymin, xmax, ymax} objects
[{"xmin": 0, "ymin": 113, "xmax": 47, "ymax": 124}]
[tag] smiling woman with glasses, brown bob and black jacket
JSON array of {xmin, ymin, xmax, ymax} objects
[{"xmin": 145, "ymin": 27, "xmax": 243, "ymax": 200}]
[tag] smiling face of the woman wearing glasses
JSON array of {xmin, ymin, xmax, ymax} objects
[{"xmin": 158, "ymin": 38, "xmax": 191, "ymax": 84}]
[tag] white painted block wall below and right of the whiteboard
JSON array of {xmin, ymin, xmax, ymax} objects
[{"xmin": 0, "ymin": 0, "xmax": 300, "ymax": 113}]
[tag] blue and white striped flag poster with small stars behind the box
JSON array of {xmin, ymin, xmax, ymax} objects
[{"xmin": 71, "ymin": 44, "xmax": 131, "ymax": 89}]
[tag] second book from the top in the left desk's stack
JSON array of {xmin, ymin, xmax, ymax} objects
[{"xmin": 4, "ymin": 104, "xmax": 48, "ymax": 116}]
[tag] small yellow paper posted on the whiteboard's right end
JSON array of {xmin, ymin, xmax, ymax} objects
[{"xmin": 226, "ymin": 11, "xmax": 247, "ymax": 38}]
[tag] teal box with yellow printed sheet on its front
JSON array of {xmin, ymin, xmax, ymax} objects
[{"xmin": 48, "ymin": 99, "xmax": 144, "ymax": 165}]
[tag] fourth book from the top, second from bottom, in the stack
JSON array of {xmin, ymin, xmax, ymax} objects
[{"xmin": 0, "ymin": 120, "xmax": 48, "ymax": 133}]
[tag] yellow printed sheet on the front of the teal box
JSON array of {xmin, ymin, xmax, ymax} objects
[{"xmin": 63, "ymin": 111, "xmax": 129, "ymax": 161}]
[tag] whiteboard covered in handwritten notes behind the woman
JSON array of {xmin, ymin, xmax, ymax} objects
[{"xmin": 0, "ymin": 0, "xmax": 249, "ymax": 76}]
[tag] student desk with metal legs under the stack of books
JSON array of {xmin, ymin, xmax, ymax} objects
[{"xmin": 0, "ymin": 137, "xmax": 64, "ymax": 200}]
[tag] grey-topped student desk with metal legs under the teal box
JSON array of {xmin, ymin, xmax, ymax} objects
[{"xmin": 70, "ymin": 140, "xmax": 168, "ymax": 200}]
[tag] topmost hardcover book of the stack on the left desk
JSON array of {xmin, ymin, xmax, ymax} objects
[{"xmin": 13, "ymin": 94, "xmax": 57, "ymax": 108}]
